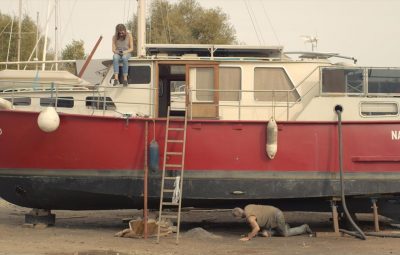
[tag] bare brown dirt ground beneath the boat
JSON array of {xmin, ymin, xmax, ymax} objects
[{"xmin": 0, "ymin": 199, "xmax": 400, "ymax": 255}]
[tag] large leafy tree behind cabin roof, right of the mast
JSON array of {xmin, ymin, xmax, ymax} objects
[{"xmin": 127, "ymin": 0, "xmax": 237, "ymax": 47}]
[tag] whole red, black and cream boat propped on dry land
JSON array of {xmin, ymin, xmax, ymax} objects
[{"xmin": 0, "ymin": 0, "xmax": 400, "ymax": 222}]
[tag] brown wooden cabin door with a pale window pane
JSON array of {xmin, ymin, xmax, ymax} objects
[{"xmin": 186, "ymin": 64, "xmax": 219, "ymax": 119}]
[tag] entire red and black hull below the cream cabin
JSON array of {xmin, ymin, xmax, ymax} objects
[{"xmin": 0, "ymin": 111, "xmax": 400, "ymax": 215}]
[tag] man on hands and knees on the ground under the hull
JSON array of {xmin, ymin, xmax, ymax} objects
[{"xmin": 232, "ymin": 204, "xmax": 312, "ymax": 241}]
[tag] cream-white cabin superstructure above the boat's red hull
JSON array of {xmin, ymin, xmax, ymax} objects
[{"xmin": 0, "ymin": 45, "xmax": 400, "ymax": 121}]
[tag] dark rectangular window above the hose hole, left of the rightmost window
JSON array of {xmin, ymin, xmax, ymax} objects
[{"xmin": 322, "ymin": 68, "xmax": 364, "ymax": 94}]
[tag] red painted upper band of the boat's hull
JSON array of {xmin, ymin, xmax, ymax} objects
[{"xmin": 0, "ymin": 111, "xmax": 400, "ymax": 172}]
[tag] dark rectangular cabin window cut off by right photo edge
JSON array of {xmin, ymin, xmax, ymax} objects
[{"xmin": 367, "ymin": 68, "xmax": 400, "ymax": 94}]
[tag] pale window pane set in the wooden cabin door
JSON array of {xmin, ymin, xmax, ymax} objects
[{"xmin": 196, "ymin": 67, "xmax": 214, "ymax": 101}]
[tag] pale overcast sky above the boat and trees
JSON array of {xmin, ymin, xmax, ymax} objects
[{"xmin": 0, "ymin": 0, "xmax": 400, "ymax": 67}]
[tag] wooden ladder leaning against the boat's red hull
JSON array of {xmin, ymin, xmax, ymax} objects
[{"xmin": 157, "ymin": 107, "xmax": 187, "ymax": 244}]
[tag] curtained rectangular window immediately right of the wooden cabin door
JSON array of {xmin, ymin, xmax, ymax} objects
[{"xmin": 219, "ymin": 67, "xmax": 242, "ymax": 101}]
